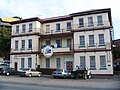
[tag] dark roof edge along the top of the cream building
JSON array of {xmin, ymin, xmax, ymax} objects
[{"xmin": 11, "ymin": 8, "xmax": 112, "ymax": 26}]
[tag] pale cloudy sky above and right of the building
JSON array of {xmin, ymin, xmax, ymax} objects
[{"xmin": 0, "ymin": 0, "xmax": 120, "ymax": 39}]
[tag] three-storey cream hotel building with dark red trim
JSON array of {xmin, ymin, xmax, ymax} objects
[{"xmin": 10, "ymin": 8, "xmax": 113, "ymax": 75}]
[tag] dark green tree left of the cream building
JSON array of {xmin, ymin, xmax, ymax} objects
[{"xmin": 0, "ymin": 26, "xmax": 11, "ymax": 59}]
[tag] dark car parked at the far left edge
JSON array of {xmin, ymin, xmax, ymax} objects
[{"xmin": 2, "ymin": 68, "xmax": 18, "ymax": 76}]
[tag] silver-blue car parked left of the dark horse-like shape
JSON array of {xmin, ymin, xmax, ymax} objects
[{"xmin": 52, "ymin": 69, "xmax": 71, "ymax": 78}]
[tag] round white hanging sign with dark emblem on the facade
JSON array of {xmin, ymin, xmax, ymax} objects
[{"xmin": 43, "ymin": 45, "xmax": 53, "ymax": 58}]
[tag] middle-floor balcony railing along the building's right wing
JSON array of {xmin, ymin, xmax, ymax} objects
[{"xmin": 74, "ymin": 43, "xmax": 111, "ymax": 49}]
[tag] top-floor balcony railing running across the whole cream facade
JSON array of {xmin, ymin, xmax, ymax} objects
[{"xmin": 12, "ymin": 21, "xmax": 110, "ymax": 35}]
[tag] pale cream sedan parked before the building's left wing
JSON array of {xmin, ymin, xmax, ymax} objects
[{"xmin": 19, "ymin": 68, "xmax": 42, "ymax": 77}]
